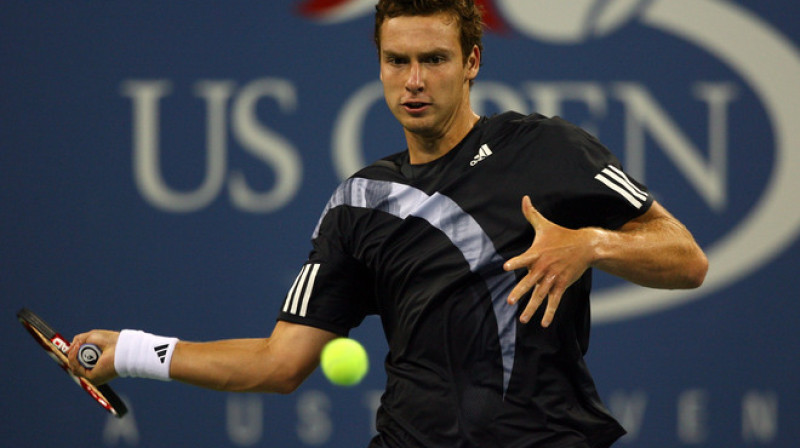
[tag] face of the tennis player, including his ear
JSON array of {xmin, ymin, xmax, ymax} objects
[{"xmin": 380, "ymin": 13, "xmax": 480, "ymax": 142}]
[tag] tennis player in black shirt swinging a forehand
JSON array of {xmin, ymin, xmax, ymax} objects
[{"xmin": 70, "ymin": 0, "xmax": 708, "ymax": 448}]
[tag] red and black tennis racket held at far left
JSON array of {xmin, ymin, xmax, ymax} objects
[{"xmin": 17, "ymin": 308, "xmax": 128, "ymax": 418}]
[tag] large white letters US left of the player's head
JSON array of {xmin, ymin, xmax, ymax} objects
[{"xmin": 121, "ymin": 78, "xmax": 302, "ymax": 213}]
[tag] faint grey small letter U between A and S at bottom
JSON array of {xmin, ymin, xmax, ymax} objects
[{"xmin": 225, "ymin": 394, "xmax": 264, "ymax": 446}]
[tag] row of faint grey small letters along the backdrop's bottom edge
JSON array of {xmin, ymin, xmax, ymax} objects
[{"xmin": 212, "ymin": 388, "xmax": 780, "ymax": 446}]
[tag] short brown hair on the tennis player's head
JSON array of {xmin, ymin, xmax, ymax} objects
[{"xmin": 374, "ymin": 0, "xmax": 483, "ymax": 62}]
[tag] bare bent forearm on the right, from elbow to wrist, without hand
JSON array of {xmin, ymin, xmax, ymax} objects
[{"xmin": 589, "ymin": 204, "xmax": 708, "ymax": 289}]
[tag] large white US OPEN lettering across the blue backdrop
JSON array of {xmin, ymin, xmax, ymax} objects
[{"xmin": 122, "ymin": 79, "xmax": 736, "ymax": 213}]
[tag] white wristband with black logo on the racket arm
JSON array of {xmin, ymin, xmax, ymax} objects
[{"xmin": 114, "ymin": 330, "xmax": 178, "ymax": 381}]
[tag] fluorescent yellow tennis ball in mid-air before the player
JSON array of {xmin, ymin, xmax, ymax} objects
[{"xmin": 320, "ymin": 338, "xmax": 369, "ymax": 386}]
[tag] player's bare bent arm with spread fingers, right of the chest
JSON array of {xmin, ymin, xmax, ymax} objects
[{"xmin": 504, "ymin": 196, "xmax": 708, "ymax": 327}]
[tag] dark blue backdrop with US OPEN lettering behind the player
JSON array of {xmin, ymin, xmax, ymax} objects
[{"xmin": 0, "ymin": 0, "xmax": 800, "ymax": 448}]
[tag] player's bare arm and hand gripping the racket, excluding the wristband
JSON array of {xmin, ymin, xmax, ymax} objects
[{"xmin": 69, "ymin": 321, "xmax": 338, "ymax": 393}]
